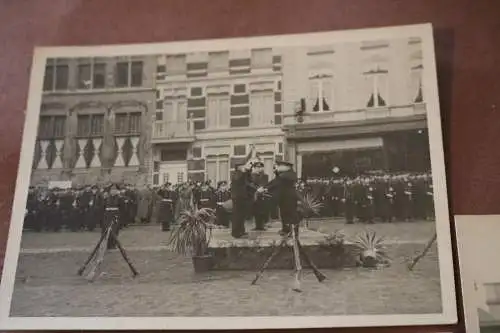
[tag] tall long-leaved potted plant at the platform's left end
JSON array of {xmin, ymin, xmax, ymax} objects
[{"xmin": 168, "ymin": 208, "xmax": 215, "ymax": 273}]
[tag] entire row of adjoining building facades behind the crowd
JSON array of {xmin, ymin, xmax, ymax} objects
[{"xmin": 32, "ymin": 39, "xmax": 430, "ymax": 185}]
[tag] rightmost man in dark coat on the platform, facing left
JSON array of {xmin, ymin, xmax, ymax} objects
[{"xmin": 264, "ymin": 161, "xmax": 300, "ymax": 236}]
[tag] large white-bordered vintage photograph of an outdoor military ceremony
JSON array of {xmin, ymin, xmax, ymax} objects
[{"xmin": 0, "ymin": 24, "xmax": 457, "ymax": 329}]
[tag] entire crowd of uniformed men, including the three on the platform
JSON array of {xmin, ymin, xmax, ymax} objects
[{"xmin": 24, "ymin": 163, "xmax": 434, "ymax": 238}]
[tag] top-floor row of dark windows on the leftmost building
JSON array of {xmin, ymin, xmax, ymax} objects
[{"xmin": 43, "ymin": 59, "xmax": 144, "ymax": 92}]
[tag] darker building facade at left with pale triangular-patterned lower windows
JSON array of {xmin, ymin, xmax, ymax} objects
[{"xmin": 31, "ymin": 56, "xmax": 155, "ymax": 184}]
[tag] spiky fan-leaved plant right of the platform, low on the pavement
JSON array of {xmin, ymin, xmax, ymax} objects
[{"xmin": 354, "ymin": 231, "xmax": 389, "ymax": 268}]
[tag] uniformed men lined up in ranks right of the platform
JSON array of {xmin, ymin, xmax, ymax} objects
[{"xmin": 297, "ymin": 173, "xmax": 434, "ymax": 223}]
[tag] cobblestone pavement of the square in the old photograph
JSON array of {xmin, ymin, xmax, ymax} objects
[{"xmin": 11, "ymin": 222, "xmax": 441, "ymax": 316}]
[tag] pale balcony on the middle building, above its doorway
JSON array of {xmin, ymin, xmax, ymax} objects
[{"xmin": 151, "ymin": 119, "xmax": 195, "ymax": 144}]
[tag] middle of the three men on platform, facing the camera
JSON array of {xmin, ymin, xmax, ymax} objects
[{"xmin": 250, "ymin": 161, "xmax": 269, "ymax": 231}]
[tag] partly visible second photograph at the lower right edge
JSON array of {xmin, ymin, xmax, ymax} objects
[{"xmin": 455, "ymin": 215, "xmax": 500, "ymax": 333}]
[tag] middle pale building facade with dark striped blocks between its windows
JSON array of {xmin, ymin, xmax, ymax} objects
[{"xmin": 152, "ymin": 48, "xmax": 284, "ymax": 184}]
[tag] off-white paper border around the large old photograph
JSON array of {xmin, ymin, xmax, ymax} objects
[{"xmin": 0, "ymin": 23, "xmax": 457, "ymax": 330}]
